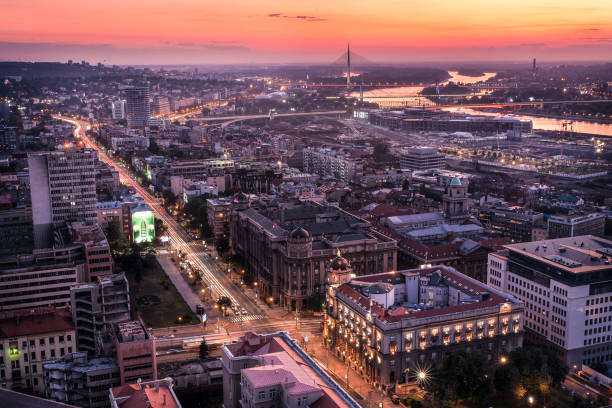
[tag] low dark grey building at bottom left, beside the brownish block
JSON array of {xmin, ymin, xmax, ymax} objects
[{"xmin": 43, "ymin": 353, "xmax": 120, "ymax": 408}]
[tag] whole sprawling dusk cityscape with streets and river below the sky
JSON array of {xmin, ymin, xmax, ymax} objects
[{"xmin": 0, "ymin": 1, "xmax": 612, "ymax": 408}]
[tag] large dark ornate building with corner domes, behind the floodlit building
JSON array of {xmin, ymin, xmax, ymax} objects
[{"xmin": 230, "ymin": 194, "xmax": 397, "ymax": 311}]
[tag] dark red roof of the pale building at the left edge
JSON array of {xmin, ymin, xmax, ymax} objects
[{"xmin": 0, "ymin": 308, "xmax": 74, "ymax": 338}]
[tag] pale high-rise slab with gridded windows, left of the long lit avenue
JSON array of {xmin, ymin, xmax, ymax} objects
[{"xmin": 28, "ymin": 149, "xmax": 98, "ymax": 248}]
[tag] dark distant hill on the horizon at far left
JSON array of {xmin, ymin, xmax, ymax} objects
[{"xmin": 0, "ymin": 61, "xmax": 100, "ymax": 79}]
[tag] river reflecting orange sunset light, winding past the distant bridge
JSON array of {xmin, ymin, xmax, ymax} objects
[{"xmin": 351, "ymin": 71, "xmax": 612, "ymax": 136}]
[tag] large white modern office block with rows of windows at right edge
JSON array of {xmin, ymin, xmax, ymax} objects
[{"xmin": 488, "ymin": 235, "xmax": 612, "ymax": 367}]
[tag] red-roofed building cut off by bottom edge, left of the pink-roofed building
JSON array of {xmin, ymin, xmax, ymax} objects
[{"xmin": 109, "ymin": 377, "xmax": 181, "ymax": 408}]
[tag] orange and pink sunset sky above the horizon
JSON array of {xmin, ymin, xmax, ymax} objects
[{"xmin": 0, "ymin": 0, "xmax": 612, "ymax": 64}]
